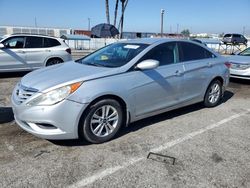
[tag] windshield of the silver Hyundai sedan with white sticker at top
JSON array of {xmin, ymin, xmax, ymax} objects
[{"xmin": 77, "ymin": 43, "xmax": 148, "ymax": 67}]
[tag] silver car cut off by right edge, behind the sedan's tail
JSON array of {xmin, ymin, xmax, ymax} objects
[{"xmin": 228, "ymin": 47, "xmax": 250, "ymax": 80}]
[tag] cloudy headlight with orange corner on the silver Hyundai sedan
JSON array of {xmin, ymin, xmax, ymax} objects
[{"xmin": 27, "ymin": 82, "xmax": 82, "ymax": 106}]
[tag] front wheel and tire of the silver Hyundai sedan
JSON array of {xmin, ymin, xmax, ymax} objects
[{"xmin": 79, "ymin": 99, "xmax": 123, "ymax": 144}]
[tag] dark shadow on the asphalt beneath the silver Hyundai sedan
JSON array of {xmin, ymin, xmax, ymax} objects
[{"xmin": 50, "ymin": 91, "xmax": 234, "ymax": 146}]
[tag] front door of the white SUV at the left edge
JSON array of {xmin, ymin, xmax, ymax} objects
[{"xmin": 0, "ymin": 36, "xmax": 29, "ymax": 72}]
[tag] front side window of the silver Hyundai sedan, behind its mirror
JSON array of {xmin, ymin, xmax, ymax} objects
[{"xmin": 140, "ymin": 42, "xmax": 178, "ymax": 66}]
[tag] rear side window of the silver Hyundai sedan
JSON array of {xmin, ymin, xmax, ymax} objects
[{"xmin": 179, "ymin": 42, "xmax": 216, "ymax": 61}]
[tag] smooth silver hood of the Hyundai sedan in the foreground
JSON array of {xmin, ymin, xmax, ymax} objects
[{"xmin": 21, "ymin": 61, "xmax": 119, "ymax": 92}]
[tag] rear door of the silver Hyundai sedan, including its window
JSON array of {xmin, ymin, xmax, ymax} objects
[{"xmin": 178, "ymin": 42, "xmax": 216, "ymax": 102}]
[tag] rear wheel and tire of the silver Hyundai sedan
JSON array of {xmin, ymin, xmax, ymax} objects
[{"xmin": 204, "ymin": 80, "xmax": 222, "ymax": 107}]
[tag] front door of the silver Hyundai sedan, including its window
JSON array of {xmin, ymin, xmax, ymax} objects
[{"xmin": 134, "ymin": 42, "xmax": 184, "ymax": 116}]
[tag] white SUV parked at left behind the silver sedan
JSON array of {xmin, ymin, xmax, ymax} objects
[{"xmin": 0, "ymin": 34, "xmax": 72, "ymax": 72}]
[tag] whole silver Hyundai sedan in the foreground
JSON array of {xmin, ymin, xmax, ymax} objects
[{"xmin": 12, "ymin": 38, "xmax": 229, "ymax": 143}]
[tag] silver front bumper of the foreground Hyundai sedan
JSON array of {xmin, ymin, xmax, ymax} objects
[{"xmin": 11, "ymin": 95, "xmax": 87, "ymax": 140}]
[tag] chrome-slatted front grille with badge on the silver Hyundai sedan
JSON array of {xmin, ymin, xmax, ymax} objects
[{"xmin": 14, "ymin": 84, "xmax": 38, "ymax": 104}]
